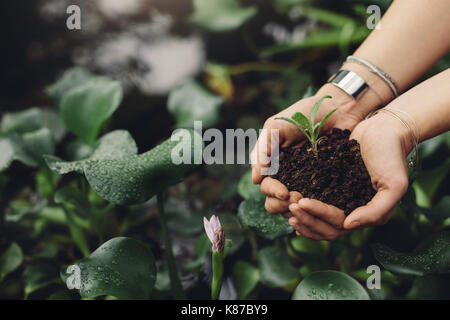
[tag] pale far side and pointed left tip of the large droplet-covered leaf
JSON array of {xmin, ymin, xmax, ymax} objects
[{"xmin": 44, "ymin": 130, "xmax": 138, "ymax": 174}]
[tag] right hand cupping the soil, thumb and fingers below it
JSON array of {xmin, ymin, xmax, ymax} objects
[{"xmin": 289, "ymin": 112, "xmax": 412, "ymax": 240}]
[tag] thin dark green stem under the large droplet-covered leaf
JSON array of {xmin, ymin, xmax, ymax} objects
[{"xmin": 156, "ymin": 192, "xmax": 186, "ymax": 300}]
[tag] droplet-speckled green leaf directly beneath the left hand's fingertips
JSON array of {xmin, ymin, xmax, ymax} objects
[{"xmin": 238, "ymin": 199, "xmax": 294, "ymax": 240}]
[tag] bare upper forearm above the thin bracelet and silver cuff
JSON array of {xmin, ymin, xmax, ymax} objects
[{"xmin": 354, "ymin": 0, "xmax": 450, "ymax": 91}]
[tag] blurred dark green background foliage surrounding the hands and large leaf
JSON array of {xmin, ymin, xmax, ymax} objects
[{"xmin": 0, "ymin": 0, "xmax": 450, "ymax": 299}]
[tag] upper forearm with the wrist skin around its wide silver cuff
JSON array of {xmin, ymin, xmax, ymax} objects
[{"xmin": 318, "ymin": 0, "xmax": 450, "ymax": 119}]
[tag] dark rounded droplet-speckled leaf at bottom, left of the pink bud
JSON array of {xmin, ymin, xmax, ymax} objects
[{"xmin": 66, "ymin": 237, "xmax": 156, "ymax": 300}]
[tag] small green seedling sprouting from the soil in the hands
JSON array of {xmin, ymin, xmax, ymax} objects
[{"xmin": 275, "ymin": 96, "xmax": 337, "ymax": 157}]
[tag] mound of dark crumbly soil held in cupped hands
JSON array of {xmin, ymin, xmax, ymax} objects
[{"xmin": 273, "ymin": 128, "xmax": 375, "ymax": 214}]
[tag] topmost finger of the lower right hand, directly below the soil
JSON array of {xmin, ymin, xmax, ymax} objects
[{"xmin": 298, "ymin": 198, "xmax": 346, "ymax": 229}]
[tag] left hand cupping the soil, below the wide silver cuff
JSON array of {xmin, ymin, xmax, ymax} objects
[{"xmin": 251, "ymin": 84, "xmax": 367, "ymax": 214}]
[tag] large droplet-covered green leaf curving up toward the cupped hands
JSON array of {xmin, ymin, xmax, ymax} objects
[{"xmin": 84, "ymin": 129, "xmax": 203, "ymax": 204}]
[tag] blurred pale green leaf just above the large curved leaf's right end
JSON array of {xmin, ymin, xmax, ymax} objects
[{"xmin": 167, "ymin": 80, "xmax": 224, "ymax": 128}]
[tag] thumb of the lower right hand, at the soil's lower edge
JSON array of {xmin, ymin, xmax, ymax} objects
[{"xmin": 344, "ymin": 189, "xmax": 403, "ymax": 230}]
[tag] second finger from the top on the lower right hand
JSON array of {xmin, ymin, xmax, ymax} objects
[{"xmin": 289, "ymin": 204, "xmax": 342, "ymax": 241}]
